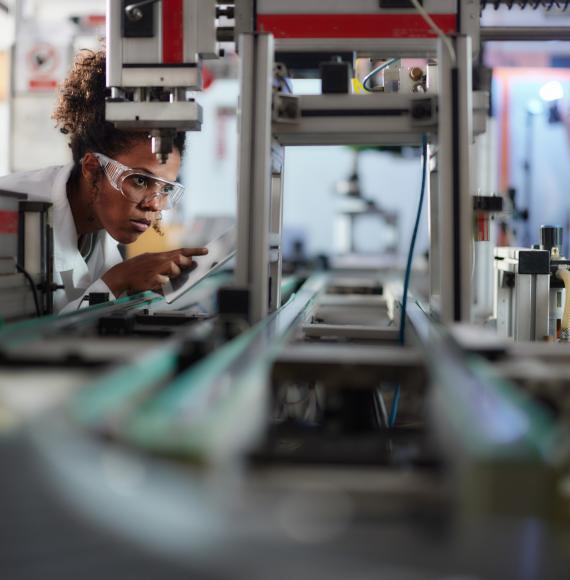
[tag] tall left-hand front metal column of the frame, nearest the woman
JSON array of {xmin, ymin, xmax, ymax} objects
[{"xmin": 236, "ymin": 34, "xmax": 273, "ymax": 324}]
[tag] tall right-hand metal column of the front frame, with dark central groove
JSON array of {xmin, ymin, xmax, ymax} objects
[{"xmin": 438, "ymin": 36, "xmax": 473, "ymax": 323}]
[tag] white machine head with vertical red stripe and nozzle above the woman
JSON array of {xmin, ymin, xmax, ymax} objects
[{"xmin": 106, "ymin": 0, "xmax": 218, "ymax": 160}]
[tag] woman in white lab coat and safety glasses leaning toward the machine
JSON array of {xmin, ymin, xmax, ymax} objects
[{"xmin": 0, "ymin": 51, "xmax": 207, "ymax": 312}]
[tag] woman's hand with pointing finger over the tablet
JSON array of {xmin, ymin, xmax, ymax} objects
[{"xmin": 101, "ymin": 248, "xmax": 208, "ymax": 296}]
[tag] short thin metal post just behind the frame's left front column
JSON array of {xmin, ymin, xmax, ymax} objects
[{"xmin": 269, "ymin": 146, "xmax": 285, "ymax": 312}]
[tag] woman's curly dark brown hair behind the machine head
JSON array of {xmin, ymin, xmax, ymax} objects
[{"xmin": 52, "ymin": 50, "xmax": 185, "ymax": 163}]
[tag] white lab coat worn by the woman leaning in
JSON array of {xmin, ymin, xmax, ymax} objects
[{"xmin": 0, "ymin": 163, "xmax": 122, "ymax": 313}]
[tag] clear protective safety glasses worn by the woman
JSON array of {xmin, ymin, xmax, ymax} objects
[{"xmin": 93, "ymin": 153, "xmax": 184, "ymax": 209}]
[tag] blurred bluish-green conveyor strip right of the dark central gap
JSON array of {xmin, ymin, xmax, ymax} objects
[{"xmin": 409, "ymin": 303, "xmax": 563, "ymax": 462}]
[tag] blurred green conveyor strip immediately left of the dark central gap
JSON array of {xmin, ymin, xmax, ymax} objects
[{"xmin": 120, "ymin": 284, "xmax": 320, "ymax": 461}]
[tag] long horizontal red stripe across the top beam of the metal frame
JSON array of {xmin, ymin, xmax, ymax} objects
[{"xmin": 257, "ymin": 14, "xmax": 457, "ymax": 38}]
